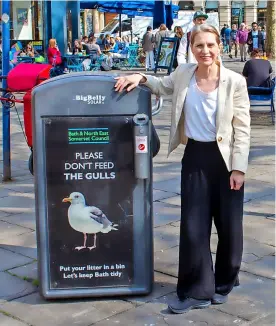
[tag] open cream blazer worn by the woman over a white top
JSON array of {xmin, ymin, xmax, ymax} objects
[{"xmin": 143, "ymin": 63, "xmax": 250, "ymax": 173}]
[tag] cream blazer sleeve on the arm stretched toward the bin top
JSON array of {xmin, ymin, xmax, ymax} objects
[{"xmin": 140, "ymin": 67, "xmax": 179, "ymax": 96}]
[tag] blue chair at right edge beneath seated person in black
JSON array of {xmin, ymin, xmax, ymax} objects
[{"xmin": 247, "ymin": 77, "xmax": 275, "ymax": 125}]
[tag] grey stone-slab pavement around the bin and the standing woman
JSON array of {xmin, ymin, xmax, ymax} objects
[{"xmin": 0, "ymin": 61, "xmax": 275, "ymax": 326}]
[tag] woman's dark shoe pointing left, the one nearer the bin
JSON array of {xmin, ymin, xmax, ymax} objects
[{"xmin": 168, "ymin": 298, "xmax": 211, "ymax": 314}]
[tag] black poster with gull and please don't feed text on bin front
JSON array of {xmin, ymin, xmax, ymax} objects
[{"xmin": 43, "ymin": 116, "xmax": 136, "ymax": 289}]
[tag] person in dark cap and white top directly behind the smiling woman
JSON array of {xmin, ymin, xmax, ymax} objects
[{"xmin": 177, "ymin": 11, "xmax": 208, "ymax": 65}]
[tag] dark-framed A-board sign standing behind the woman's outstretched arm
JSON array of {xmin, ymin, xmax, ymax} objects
[{"xmin": 154, "ymin": 37, "xmax": 177, "ymax": 74}]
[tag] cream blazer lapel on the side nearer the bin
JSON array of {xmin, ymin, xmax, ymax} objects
[{"xmin": 174, "ymin": 64, "xmax": 197, "ymax": 128}]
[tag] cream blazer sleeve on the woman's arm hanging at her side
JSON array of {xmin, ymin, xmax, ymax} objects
[{"xmin": 232, "ymin": 77, "xmax": 250, "ymax": 173}]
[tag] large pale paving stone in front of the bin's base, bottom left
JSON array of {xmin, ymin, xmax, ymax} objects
[{"xmin": 0, "ymin": 293, "xmax": 133, "ymax": 326}]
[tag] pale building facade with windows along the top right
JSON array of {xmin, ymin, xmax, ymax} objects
[{"xmin": 177, "ymin": 0, "xmax": 267, "ymax": 26}]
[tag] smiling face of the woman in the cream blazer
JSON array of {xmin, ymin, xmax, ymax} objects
[{"xmin": 192, "ymin": 32, "xmax": 219, "ymax": 66}]
